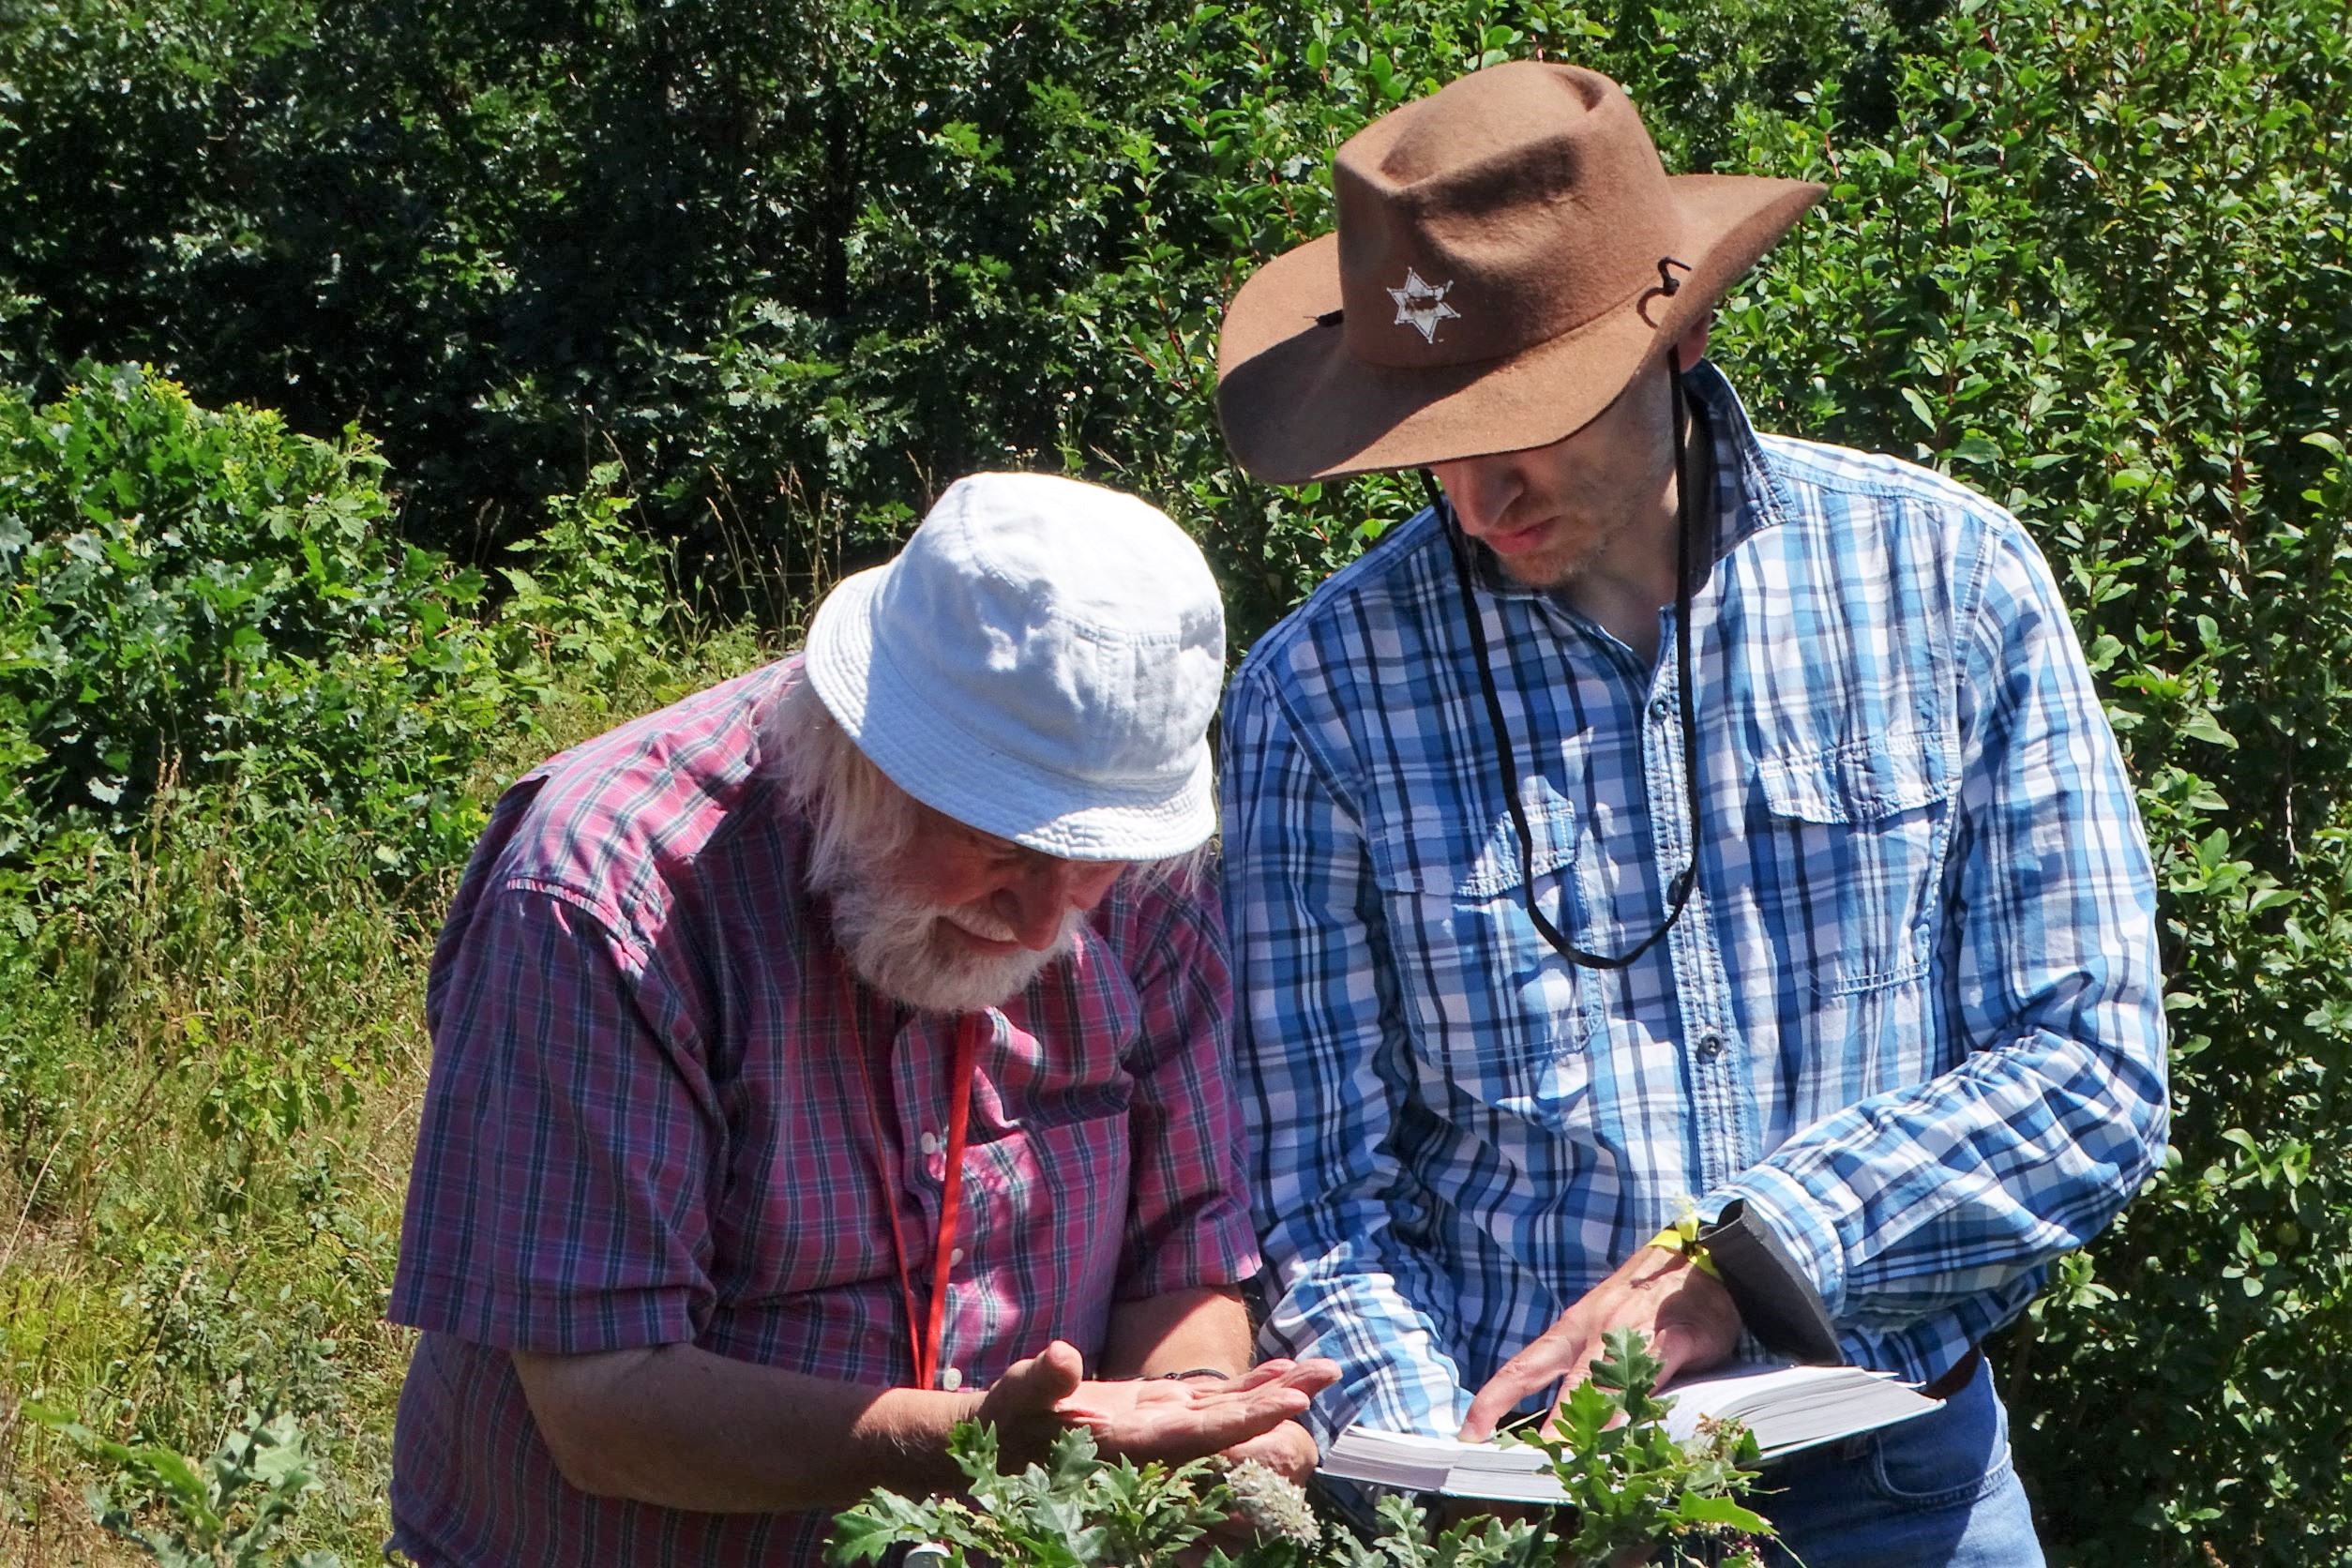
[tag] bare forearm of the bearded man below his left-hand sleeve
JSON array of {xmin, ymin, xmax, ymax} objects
[{"xmin": 515, "ymin": 1345, "xmax": 981, "ymax": 1514}]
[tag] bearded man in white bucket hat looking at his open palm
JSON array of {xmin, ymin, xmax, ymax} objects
[{"xmin": 390, "ymin": 475, "xmax": 1336, "ymax": 1565}]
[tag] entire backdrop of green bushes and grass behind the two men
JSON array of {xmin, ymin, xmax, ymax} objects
[{"xmin": 0, "ymin": 0, "xmax": 2352, "ymax": 1568}]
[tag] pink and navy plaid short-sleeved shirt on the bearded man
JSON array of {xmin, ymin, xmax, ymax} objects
[{"xmin": 390, "ymin": 660, "xmax": 1259, "ymax": 1565}]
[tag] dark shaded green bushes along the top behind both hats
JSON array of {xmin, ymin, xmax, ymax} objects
[{"xmin": 0, "ymin": 0, "xmax": 1891, "ymax": 635}]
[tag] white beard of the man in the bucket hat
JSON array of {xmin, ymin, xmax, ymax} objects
[{"xmin": 828, "ymin": 872, "xmax": 1087, "ymax": 1013}]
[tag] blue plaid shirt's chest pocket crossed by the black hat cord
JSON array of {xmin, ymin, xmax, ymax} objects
[{"xmin": 1371, "ymin": 778, "xmax": 1590, "ymax": 1122}]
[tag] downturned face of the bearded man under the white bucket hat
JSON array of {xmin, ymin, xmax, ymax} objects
[{"xmin": 833, "ymin": 804, "xmax": 1126, "ymax": 1013}]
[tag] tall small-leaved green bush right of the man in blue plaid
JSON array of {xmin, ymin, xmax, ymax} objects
[{"xmin": 1719, "ymin": 0, "xmax": 2352, "ymax": 1568}]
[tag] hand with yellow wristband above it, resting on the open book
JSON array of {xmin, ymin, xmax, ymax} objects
[{"xmin": 1460, "ymin": 1246, "xmax": 1741, "ymax": 1443}]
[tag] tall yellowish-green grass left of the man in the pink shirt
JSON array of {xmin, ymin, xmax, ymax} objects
[{"xmin": 0, "ymin": 630, "xmax": 764, "ymax": 1568}]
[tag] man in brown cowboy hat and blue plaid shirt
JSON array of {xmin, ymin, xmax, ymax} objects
[{"xmin": 1218, "ymin": 64, "xmax": 2166, "ymax": 1568}]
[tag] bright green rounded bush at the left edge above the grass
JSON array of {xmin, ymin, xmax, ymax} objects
[{"xmin": 0, "ymin": 367, "xmax": 501, "ymax": 888}]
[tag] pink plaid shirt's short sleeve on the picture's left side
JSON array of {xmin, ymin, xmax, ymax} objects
[{"xmin": 388, "ymin": 883, "xmax": 722, "ymax": 1354}]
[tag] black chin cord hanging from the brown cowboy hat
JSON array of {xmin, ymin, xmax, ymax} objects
[{"xmin": 1421, "ymin": 353, "xmax": 1698, "ymax": 969}]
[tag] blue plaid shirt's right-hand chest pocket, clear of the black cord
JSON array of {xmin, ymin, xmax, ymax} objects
[{"xmin": 1750, "ymin": 729, "xmax": 1957, "ymax": 997}]
